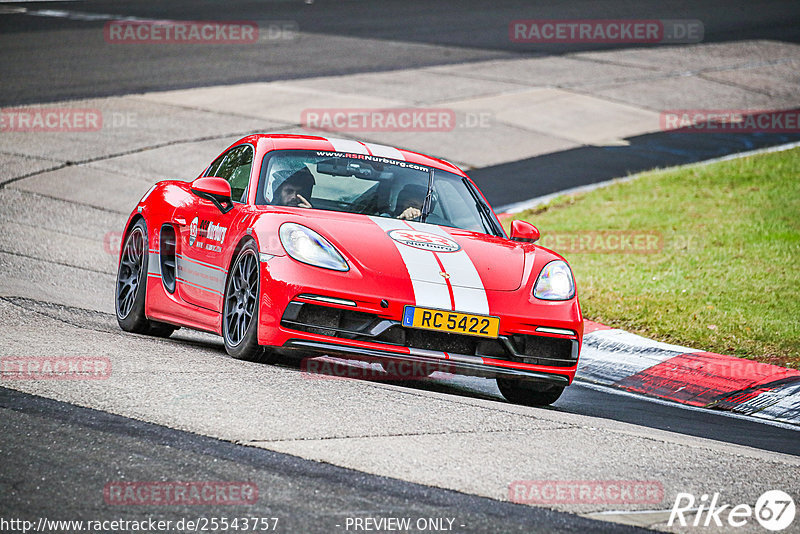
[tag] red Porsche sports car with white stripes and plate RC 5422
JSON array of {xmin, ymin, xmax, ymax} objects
[{"xmin": 115, "ymin": 134, "xmax": 583, "ymax": 405}]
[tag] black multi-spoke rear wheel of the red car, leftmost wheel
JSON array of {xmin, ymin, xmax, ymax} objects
[{"xmin": 114, "ymin": 219, "xmax": 177, "ymax": 337}]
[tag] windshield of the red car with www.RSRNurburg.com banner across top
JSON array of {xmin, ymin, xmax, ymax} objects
[{"xmin": 256, "ymin": 150, "xmax": 504, "ymax": 236}]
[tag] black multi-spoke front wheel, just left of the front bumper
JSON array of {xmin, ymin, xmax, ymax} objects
[{"xmin": 222, "ymin": 241, "xmax": 275, "ymax": 363}]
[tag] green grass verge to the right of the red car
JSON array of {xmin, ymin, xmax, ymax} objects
[{"xmin": 505, "ymin": 149, "xmax": 800, "ymax": 368}]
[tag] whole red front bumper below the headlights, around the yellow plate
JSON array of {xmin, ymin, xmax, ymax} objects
[{"xmin": 258, "ymin": 257, "xmax": 583, "ymax": 385}]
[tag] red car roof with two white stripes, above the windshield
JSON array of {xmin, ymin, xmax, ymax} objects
[{"xmin": 237, "ymin": 134, "xmax": 466, "ymax": 176}]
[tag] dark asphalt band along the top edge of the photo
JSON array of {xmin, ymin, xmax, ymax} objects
[{"xmin": 0, "ymin": 0, "xmax": 800, "ymax": 106}]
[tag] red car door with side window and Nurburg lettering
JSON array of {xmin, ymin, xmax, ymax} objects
[{"xmin": 176, "ymin": 144, "xmax": 254, "ymax": 312}]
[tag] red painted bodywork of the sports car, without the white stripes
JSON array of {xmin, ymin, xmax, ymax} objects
[{"xmin": 117, "ymin": 134, "xmax": 583, "ymax": 383}]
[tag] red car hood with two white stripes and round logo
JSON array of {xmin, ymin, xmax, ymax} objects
[{"xmin": 272, "ymin": 211, "xmax": 525, "ymax": 291}]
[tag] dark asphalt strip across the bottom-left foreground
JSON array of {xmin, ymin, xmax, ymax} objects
[{"xmin": 0, "ymin": 388, "xmax": 643, "ymax": 533}]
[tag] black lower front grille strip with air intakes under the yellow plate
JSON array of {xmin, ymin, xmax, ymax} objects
[{"xmin": 281, "ymin": 301, "xmax": 578, "ymax": 367}]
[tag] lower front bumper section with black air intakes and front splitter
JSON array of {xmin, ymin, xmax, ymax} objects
[{"xmin": 272, "ymin": 295, "xmax": 580, "ymax": 385}]
